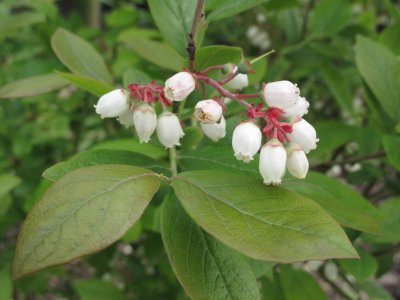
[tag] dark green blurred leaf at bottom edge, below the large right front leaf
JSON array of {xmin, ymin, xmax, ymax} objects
[{"xmin": 279, "ymin": 265, "xmax": 328, "ymax": 300}]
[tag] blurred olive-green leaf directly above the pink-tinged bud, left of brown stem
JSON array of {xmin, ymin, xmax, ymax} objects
[{"xmin": 123, "ymin": 35, "xmax": 184, "ymax": 71}]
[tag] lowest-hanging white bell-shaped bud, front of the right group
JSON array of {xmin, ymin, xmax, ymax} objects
[{"xmin": 259, "ymin": 139, "xmax": 286, "ymax": 185}]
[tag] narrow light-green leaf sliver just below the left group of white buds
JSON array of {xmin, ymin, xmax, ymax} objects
[{"xmin": 91, "ymin": 138, "xmax": 167, "ymax": 159}]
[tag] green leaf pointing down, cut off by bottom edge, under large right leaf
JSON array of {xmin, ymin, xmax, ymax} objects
[{"xmin": 161, "ymin": 193, "xmax": 260, "ymax": 300}]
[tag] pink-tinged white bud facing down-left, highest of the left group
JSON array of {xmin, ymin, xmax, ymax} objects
[{"xmin": 164, "ymin": 72, "xmax": 196, "ymax": 101}]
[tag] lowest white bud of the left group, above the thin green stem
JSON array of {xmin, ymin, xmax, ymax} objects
[{"xmin": 157, "ymin": 112, "xmax": 185, "ymax": 148}]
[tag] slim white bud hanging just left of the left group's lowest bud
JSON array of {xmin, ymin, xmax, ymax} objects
[{"xmin": 133, "ymin": 104, "xmax": 157, "ymax": 143}]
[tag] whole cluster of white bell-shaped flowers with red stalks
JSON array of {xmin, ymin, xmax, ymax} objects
[{"xmin": 95, "ymin": 66, "xmax": 318, "ymax": 185}]
